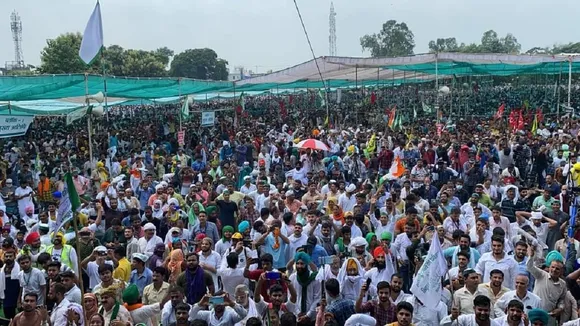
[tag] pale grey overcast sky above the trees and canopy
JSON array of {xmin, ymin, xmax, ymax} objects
[{"xmin": 0, "ymin": 0, "xmax": 580, "ymax": 72}]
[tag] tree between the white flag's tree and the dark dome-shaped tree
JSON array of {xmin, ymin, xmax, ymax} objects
[{"xmin": 123, "ymin": 50, "xmax": 166, "ymax": 77}]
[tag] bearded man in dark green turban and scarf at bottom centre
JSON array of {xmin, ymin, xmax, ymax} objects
[{"xmin": 290, "ymin": 252, "xmax": 322, "ymax": 323}]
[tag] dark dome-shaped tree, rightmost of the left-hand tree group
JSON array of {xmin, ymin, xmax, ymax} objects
[{"xmin": 169, "ymin": 48, "xmax": 228, "ymax": 80}]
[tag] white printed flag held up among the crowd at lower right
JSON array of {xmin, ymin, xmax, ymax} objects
[{"xmin": 411, "ymin": 235, "xmax": 447, "ymax": 309}]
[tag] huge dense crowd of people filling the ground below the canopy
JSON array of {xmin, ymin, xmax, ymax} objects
[{"xmin": 0, "ymin": 84, "xmax": 580, "ymax": 326}]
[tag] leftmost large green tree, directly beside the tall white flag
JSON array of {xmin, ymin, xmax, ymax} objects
[{"xmin": 38, "ymin": 33, "xmax": 100, "ymax": 74}]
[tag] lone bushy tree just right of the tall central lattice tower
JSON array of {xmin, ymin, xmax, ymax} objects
[{"xmin": 360, "ymin": 20, "xmax": 415, "ymax": 57}]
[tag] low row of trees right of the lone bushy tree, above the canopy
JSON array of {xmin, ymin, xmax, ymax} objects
[{"xmin": 429, "ymin": 30, "xmax": 522, "ymax": 54}]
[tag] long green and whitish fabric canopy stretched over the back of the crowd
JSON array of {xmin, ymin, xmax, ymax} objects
[{"xmin": 0, "ymin": 53, "xmax": 580, "ymax": 114}]
